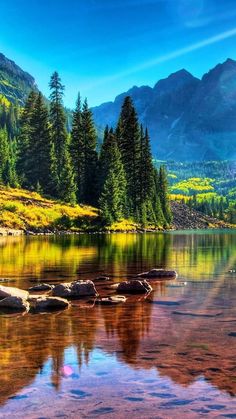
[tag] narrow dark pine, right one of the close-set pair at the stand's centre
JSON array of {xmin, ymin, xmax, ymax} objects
[{"xmin": 79, "ymin": 99, "xmax": 98, "ymax": 205}]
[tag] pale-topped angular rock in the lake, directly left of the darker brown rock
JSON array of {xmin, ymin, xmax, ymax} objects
[{"xmin": 52, "ymin": 281, "xmax": 98, "ymax": 298}]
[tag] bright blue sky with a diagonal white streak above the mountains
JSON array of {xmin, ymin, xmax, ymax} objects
[{"xmin": 0, "ymin": 0, "xmax": 236, "ymax": 108}]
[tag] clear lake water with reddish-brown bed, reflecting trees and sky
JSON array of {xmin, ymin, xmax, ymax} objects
[{"xmin": 0, "ymin": 231, "xmax": 236, "ymax": 419}]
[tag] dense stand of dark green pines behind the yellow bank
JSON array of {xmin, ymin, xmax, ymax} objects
[{"xmin": 0, "ymin": 72, "xmax": 172, "ymax": 227}]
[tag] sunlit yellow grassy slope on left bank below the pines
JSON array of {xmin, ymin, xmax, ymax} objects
[{"xmin": 0, "ymin": 187, "xmax": 98, "ymax": 231}]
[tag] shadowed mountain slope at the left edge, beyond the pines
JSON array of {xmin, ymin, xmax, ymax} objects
[{"xmin": 0, "ymin": 53, "xmax": 37, "ymax": 105}]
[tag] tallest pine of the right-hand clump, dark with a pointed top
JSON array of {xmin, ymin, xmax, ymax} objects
[{"xmin": 116, "ymin": 96, "xmax": 140, "ymax": 216}]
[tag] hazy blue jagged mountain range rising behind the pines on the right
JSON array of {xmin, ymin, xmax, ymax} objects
[{"xmin": 93, "ymin": 59, "xmax": 236, "ymax": 161}]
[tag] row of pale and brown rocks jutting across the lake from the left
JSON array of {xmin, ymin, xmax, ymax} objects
[{"xmin": 0, "ymin": 269, "xmax": 178, "ymax": 312}]
